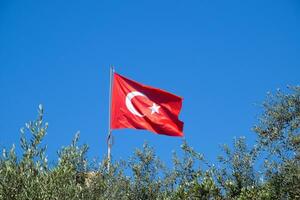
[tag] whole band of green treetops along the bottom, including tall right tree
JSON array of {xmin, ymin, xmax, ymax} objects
[{"xmin": 0, "ymin": 87, "xmax": 300, "ymax": 200}]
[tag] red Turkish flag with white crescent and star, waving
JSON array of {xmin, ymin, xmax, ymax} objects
[{"xmin": 111, "ymin": 73, "xmax": 183, "ymax": 137}]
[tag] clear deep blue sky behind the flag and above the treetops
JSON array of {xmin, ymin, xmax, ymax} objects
[{"xmin": 0, "ymin": 0, "xmax": 300, "ymax": 163}]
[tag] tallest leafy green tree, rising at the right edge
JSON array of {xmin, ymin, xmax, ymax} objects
[{"xmin": 254, "ymin": 86, "xmax": 300, "ymax": 199}]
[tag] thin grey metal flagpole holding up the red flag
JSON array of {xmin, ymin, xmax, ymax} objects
[{"xmin": 107, "ymin": 65, "xmax": 115, "ymax": 171}]
